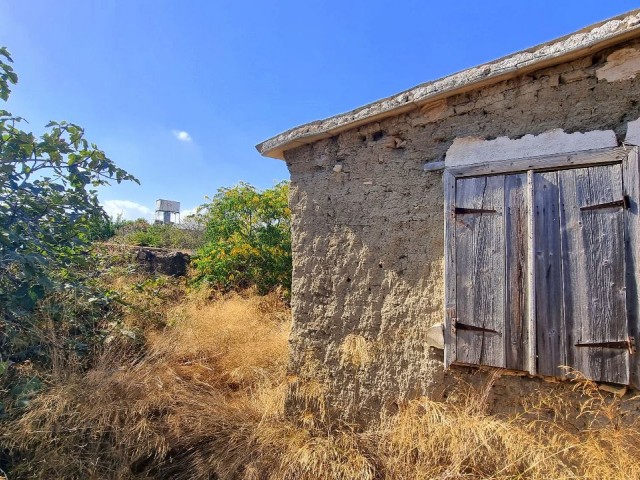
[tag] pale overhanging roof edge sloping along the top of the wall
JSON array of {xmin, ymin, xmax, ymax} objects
[{"xmin": 256, "ymin": 9, "xmax": 640, "ymax": 160}]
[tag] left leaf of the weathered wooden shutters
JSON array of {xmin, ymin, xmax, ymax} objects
[{"xmin": 454, "ymin": 174, "xmax": 528, "ymax": 370}]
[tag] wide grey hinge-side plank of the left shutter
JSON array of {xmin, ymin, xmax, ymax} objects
[{"xmin": 455, "ymin": 176, "xmax": 505, "ymax": 367}]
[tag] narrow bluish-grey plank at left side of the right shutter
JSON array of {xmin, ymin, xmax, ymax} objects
[{"xmin": 533, "ymin": 172, "xmax": 567, "ymax": 376}]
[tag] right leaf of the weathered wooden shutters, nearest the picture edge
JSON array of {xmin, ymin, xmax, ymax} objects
[{"xmin": 533, "ymin": 164, "xmax": 630, "ymax": 384}]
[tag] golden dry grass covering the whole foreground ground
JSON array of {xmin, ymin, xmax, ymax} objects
[{"xmin": 0, "ymin": 286, "xmax": 640, "ymax": 480}]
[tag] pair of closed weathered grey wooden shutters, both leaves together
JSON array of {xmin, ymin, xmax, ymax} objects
[{"xmin": 446, "ymin": 158, "xmax": 633, "ymax": 384}]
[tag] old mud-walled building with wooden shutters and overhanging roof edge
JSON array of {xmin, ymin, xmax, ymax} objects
[{"xmin": 257, "ymin": 10, "xmax": 640, "ymax": 420}]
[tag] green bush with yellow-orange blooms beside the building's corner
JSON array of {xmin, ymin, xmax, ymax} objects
[{"xmin": 193, "ymin": 182, "xmax": 291, "ymax": 293}]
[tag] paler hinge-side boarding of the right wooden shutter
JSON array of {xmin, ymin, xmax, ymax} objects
[{"xmin": 558, "ymin": 164, "xmax": 629, "ymax": 384}]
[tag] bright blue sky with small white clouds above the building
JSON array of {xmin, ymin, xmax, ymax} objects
[{"xmin": 0, "ymin": 0, "xmax": 640, "ymax": 218}]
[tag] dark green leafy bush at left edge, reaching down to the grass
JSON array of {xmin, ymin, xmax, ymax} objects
[{"xmin": 0, "ymin": 48, "xmax": 137, "ymax": 434}]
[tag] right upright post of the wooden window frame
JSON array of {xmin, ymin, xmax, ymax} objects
[{"xmin": 622, "ymin": 147, "xmax": 640, "ymax": 389}]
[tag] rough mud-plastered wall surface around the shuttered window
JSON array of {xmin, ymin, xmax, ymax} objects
[{"xmin": 285, "ymin": 41, "xmax": 640, "ymax": 422}]
